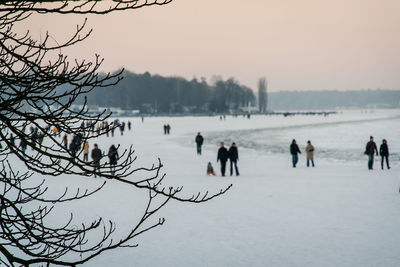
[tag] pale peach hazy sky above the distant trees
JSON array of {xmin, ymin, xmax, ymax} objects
[{"xmin": 21, "ymin": 0, "xmax": 400, "ymax": 91}]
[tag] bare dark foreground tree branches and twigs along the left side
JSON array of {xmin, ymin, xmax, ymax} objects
[{"xmin": 0, "ymin": 0, "xmax": 230, "ymax": 266}]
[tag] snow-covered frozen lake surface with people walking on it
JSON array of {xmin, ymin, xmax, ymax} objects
[{"xmin": 10, "ymin": 110, "xmax": 400, "ymax": 267}]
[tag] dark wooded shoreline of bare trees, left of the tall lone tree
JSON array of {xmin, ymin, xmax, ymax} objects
[{"xmin": 81, "ymin": 72, "xmax": 256, "ymax": 113}]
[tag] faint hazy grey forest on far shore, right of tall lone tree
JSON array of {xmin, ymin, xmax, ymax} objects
[{"xmin": 268, "ymin": 89, "xmax": 400, "ymax": 110}]
